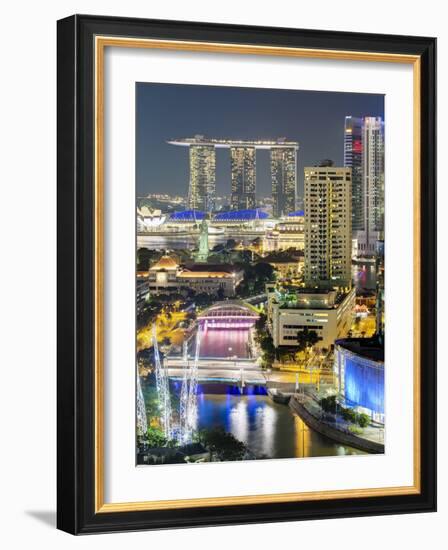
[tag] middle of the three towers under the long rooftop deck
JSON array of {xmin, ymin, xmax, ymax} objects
[{"xmin": 230, "ymin": 147, "xmax": 256, "ymax": 210}]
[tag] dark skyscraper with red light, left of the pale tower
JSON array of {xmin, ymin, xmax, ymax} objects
[{"xmin": 344, "ymin": 116, "xmax": 364, "ymax": 232}]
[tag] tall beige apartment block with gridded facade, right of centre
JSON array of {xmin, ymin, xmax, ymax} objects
[{"xmin": 305, "ymin": 166, "xmax": 352, "ymax": 288}]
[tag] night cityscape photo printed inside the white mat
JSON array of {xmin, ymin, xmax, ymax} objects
[{"xmin": 135, "ymin": 85, "xmax": 386, "ymax": 465}]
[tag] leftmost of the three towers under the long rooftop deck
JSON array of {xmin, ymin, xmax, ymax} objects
[{"xmin": 188, "ymin": 144, "xmax": 216, "ymax": 212}]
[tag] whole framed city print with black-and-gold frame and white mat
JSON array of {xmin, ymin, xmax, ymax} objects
[{"xmin": 58, "ymin": 15, "xmax": 436, "ymax": 534}]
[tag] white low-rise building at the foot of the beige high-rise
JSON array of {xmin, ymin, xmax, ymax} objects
[{"xmin": 267, "ymin": 285, "xmax": 355, "ymax": 348}]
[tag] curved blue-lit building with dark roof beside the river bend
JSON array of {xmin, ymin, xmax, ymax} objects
[{"xmin": 335, "ymin": 338, "xmax": 384, "ymax": 423}]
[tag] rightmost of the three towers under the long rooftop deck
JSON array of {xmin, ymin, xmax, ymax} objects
[{"xmin": 271, "ymin": 146, "xmax": 298, "ymax": 218}]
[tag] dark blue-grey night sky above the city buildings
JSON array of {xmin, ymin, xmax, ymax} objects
[{"xmin": 136, "ymin": 83, "xmax": 384, "ymax": 197}]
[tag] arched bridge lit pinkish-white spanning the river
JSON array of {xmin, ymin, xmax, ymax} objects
[{"xmin": 198, "ymin": 300, "xmax": 260, "ymax": 329}]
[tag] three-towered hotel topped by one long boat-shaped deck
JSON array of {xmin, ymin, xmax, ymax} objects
[{"xmin": 168, "ymin": 135, "xmax": 299, "ymax": 217}]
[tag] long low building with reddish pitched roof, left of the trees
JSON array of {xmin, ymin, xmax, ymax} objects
[{"xmin": 147, "ymin": 256, "xmax": 244, "ymax": 297}]
